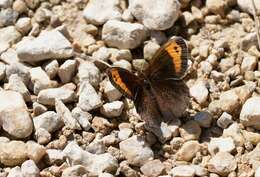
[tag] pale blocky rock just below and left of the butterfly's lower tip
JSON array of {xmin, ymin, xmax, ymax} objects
[{"xmin": 119, "ymin": 135, "xmax": 154, "ymax": 166}]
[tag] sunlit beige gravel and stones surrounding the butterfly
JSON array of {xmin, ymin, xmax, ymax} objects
[{"xmin": 0, "ymin": 0, "xmax": 260, "ymax": 177}]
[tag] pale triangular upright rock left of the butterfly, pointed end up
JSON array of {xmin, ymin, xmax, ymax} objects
[{"xmin": 78, "ymin": 81, "xmax": 102, "ymax": 111}]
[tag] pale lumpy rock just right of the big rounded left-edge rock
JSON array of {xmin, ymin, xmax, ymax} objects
[{"xmin": 33, "ymin": 111, "xmax": 63, "ymax": 133}]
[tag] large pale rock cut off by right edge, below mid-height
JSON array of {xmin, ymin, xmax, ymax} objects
[{"xmin": 240, "ymin": 97, "xmax": 260, "ymax": 130}]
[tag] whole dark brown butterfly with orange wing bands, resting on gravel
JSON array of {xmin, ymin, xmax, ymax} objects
[{"xmin": 107, "ymin": 37, "xmax": 189, "ymax": 141}]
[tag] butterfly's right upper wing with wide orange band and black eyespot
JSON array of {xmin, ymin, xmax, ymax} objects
[{"xmin": 146, "ymin": 37, "xmax": 189, "ymax": 80}]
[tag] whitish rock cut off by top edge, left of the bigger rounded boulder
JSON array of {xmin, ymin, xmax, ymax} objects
[{"xmin": 83, "ymin": 0, "xmax": 122, "ymax": 25}]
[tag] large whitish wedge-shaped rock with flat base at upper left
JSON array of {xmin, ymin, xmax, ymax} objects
[{"xmin": 16, "ymin": 30, "xmax": 73, "ymax": 62}]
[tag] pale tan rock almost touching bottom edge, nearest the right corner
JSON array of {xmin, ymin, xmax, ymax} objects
[{"xmin": 207, "ymin": 152, "xmax": 237, "ymax": 176}]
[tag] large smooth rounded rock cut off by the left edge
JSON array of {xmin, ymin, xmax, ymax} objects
[{"xmin": 0, "ymin": 91, "xmax": 33, "ymax": 138}]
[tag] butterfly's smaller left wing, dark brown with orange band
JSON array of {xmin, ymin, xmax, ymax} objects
[{"xmin": 107, "ymin": 67, "xmax": 142, "ymax": 99}]
